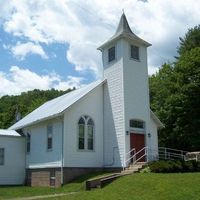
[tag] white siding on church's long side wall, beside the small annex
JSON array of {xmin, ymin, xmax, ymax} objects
[{"xmin": 25, "ymin": 118, "xmax": 62, "ymax": 168}]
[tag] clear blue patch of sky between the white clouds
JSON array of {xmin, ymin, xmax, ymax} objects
[{"xmin": 0, "ymin": 28, "xmax": 92, "ymax": 83}]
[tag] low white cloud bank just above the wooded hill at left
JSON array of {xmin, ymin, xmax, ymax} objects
[{"xmin": 0, "ymin": 66, "xmax": 84, "ymax": 96}]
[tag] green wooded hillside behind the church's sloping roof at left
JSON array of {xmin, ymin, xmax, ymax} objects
[{"xmin": 0, "ymin": 89, "xmax": 71, "ymax": 129}]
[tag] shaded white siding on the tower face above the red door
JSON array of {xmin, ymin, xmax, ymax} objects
[{"xmin": 123, "ymin": 40, "xmax": 150, "ymax": 159}]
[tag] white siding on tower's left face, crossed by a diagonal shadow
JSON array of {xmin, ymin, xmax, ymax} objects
[{"xmin": 103, "ymin": 40, "xmax": 125, "ymax": 167}]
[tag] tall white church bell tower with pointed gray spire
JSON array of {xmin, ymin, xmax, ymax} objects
[{"xmin": 99, "ymin": 13, "xmax": 154, "ymax": 166}]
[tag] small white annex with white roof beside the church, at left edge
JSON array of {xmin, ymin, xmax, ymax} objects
[{"xmin": 0, "ymin": 129, "xmax": 25, "ymax": 185}]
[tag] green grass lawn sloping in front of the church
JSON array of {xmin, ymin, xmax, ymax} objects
[{"xmin": 0, "ymin": 173, "xmax": 200, "ymax": 200}]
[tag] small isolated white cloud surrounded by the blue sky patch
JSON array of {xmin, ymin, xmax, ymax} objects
[{"xmin": 10, "ymin": 42, "xmax": 48, "ymax": 60}]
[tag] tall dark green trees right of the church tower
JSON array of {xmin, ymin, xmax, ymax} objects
[{"xmin": 150, "ymin": 26, "xmax": 200, "ymax": 150}]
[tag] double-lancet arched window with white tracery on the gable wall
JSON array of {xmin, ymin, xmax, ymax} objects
[{"xmin": 78, "ymin": 115, "xmax": 94, "ymax": 150}]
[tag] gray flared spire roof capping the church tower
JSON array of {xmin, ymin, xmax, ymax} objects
[{"xmin": 98, "ymin": 13, "xmax": 151, "ymax": 50}]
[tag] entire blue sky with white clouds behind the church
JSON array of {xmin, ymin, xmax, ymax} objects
[{"xmin": 0, "ymin": 0, "xmax": 200, "ymax": 96}]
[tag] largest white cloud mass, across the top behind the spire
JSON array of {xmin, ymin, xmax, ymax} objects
[{"xmin": 0, "ymin": 0, "xmax": 200, "ymax": 76}]
